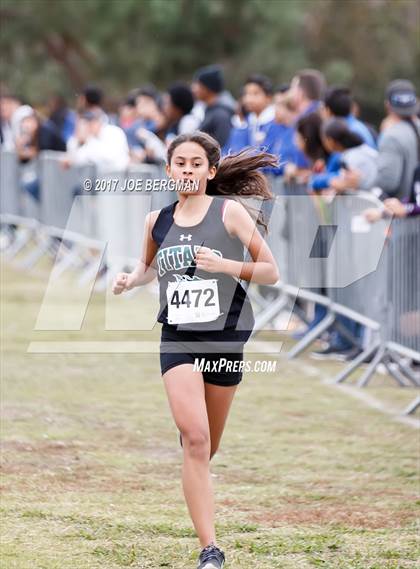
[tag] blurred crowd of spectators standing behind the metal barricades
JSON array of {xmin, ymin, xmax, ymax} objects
[{"xmin": 0, "ymin": 65, "xmax": 420, "ymax": 357}]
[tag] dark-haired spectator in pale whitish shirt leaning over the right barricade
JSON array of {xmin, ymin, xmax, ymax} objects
[{"xmin": 321, "ymin": 119, "xmax": 378, "ymax": 193}]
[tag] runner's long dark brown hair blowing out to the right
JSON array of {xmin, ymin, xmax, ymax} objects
[{"xmin": 168, "ymin": 131, "xmax": 278, "ymax": 231}]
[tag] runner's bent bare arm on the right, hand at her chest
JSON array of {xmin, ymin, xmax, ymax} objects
[{"xmin": 223, "ymin": 200, "xmax": 280, "ymax": 284}]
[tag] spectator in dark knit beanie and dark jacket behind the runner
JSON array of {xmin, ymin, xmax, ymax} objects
[{"xmin": 192, "ymin": 65, "xmax": 235, "ymax": 147}]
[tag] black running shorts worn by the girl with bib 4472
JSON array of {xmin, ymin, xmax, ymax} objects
[{"xmin": 160, "ymin": 323, "xmax": 251, "ymax": 386}]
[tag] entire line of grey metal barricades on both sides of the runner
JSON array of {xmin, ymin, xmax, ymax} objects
[{"xmin": 0, "ymin": 151, "xmax": 420, "ymax": 398}]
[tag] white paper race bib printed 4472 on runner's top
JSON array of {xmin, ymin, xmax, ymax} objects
[{"xmin": 166, "ymin": 279, "xmax": 220, "ymax": 324}]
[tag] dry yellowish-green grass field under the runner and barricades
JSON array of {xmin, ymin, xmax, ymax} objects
[{"xmin": 1, "ymin": 258, "xmax": 420, "ymax": 569}]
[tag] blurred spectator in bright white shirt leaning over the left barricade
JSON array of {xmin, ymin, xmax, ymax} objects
[{"xmin": 63, "ymin": 110, "xmax": 129, "ymax": 174}]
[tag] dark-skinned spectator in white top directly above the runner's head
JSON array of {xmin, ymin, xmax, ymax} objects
[{"xmin": 163, "ymin": 81, "xmax": 199, "ymax": 144}]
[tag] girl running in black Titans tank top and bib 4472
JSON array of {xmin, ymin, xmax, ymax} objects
[{"xmin": 113, "ymin": 132, "xmax": 279, "ymax": 569}]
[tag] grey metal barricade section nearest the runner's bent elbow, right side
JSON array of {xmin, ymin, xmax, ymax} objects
[{"xmin": 255, "ymin": 178, "xmax": 342, "ymax": 357}]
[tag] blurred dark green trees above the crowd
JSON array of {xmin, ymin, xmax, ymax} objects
[{"xmin": 0, "ymin": 0, "xmax": 419, "ymax": 124}]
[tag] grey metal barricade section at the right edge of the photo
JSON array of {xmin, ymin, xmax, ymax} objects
[{"xmin": 328, "ymin": 201, "xmax": 420, "ymax": 387}]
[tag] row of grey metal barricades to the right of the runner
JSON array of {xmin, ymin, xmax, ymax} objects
[{"xmin": 251, "ymin": 182, "xmax": 420, "ymax": 385}]
